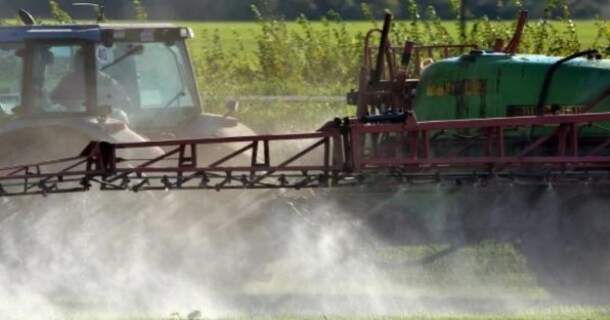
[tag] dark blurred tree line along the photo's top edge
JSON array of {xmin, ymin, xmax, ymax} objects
[{"xmin": 0, "ymin": 0, "xmax": 610, "ymax": 20}]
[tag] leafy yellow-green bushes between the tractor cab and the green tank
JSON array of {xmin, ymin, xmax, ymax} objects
[{"xmin": 196, "ymin": 6, "xmax": 362, "ymax": 94}]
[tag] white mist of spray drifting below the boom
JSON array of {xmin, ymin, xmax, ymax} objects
[{"xmin": 0, "ymin": 182, "xmax": 604, "ymax": 319}]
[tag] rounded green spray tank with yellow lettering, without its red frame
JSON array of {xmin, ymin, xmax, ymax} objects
[{"xmin": 414, "ymin": 50, "xmax": 610, "ymax": 120}]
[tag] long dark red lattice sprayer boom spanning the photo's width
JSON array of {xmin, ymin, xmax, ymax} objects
[{"xmin": 0, "ymin": 113, "xmax": 610, "ymax": 196}]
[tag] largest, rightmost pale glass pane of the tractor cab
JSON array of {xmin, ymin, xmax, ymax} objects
[{"xmin": 95, "ymin": 42, "xmax": 198, "ymax": 114}]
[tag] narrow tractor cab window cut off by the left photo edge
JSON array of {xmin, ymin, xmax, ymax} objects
[{"xmin": 0, "ymin": 44, "xmax": 23, "ymax": 115}]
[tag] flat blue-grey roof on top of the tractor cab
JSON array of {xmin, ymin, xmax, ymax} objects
[{"xmin": 0, "ymin": 23, "xmax": 191, "ymax": 43}]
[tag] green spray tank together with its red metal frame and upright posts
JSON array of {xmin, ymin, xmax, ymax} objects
[{"xmin": 348, "ymin": 11, "xmax": 610, "ymax": 127}]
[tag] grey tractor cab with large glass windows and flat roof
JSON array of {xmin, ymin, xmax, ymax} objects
[{"xmin": 0, "ymin": 23, "xmax": 252, "ymax": 139}]
